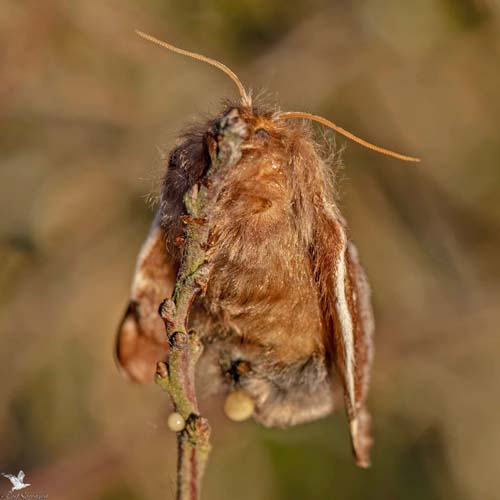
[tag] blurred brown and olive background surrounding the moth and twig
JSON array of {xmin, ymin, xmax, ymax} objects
[{"xmin": 0, "ymin": 0, "xmax": 500, "ymax": 500}]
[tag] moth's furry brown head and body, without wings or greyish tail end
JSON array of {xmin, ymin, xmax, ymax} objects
[{"xmin": 162, "ymin": 109, "xmax": 332, "ymax": 362}]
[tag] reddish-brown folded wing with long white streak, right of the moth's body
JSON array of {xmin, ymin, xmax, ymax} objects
[{"xmin": 313, "ymin": 204, "xmax": 374, "ymax": 467}]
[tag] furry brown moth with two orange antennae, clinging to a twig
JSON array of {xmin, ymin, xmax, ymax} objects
[{"xmin": 116, "ymin": 32, "xmax": 418, "ymax": 467}]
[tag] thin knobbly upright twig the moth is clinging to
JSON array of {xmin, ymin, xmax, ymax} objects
[{"xmin": 152, "ymin": 109, "xmax": 247, "ymax": 500}]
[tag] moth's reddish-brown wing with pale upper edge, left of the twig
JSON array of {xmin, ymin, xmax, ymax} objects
[{"xmin": 116, "ymin": 215, "xmax": 177, "ymax": 382}]
